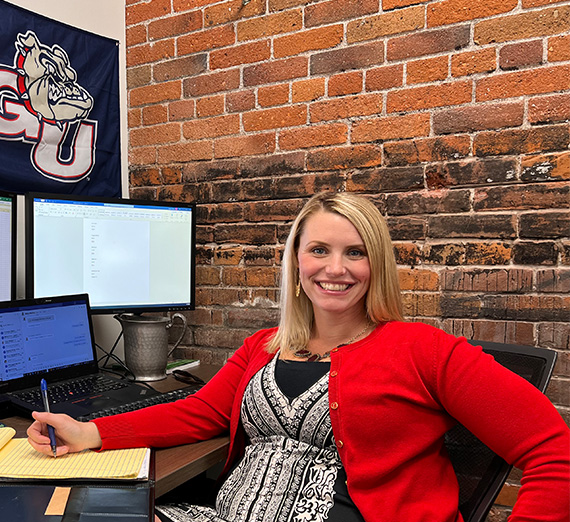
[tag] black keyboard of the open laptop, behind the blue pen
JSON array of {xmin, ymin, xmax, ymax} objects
[{"xmin": 11, "ymin": 374, "xmax": 128, "ymax": 410}]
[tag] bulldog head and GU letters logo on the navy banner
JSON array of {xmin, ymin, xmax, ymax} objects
[{"xmin": 0, "ymin": 31, "xmax": 97, "ymax": 182}]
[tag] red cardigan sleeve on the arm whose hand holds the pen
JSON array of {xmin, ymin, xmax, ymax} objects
[{"xmin": 91, "ymin": 332, "xmax": 255, "ymax": 449}]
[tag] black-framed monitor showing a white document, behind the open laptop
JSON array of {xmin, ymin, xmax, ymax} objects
[{"xmin": 26, "ymin": 194, "xmax": 196, "ymax": 314}]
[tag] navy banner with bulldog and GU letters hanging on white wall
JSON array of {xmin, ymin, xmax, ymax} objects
[{"xmin": 0, "ymin": 0, "xmax": 121, "ymax": 197}]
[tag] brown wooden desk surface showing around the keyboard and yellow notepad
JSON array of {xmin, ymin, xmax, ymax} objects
[{"xmin": 0, "ymin": 364, "xmax": 229, "ymax": 497}]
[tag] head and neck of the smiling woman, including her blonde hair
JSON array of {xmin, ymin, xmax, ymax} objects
[{"xmin": 268, "ymin": 192, "xmax": 402, "ymax": 358}]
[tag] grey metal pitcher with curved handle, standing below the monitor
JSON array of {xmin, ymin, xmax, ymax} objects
[{"xmin": 115, "ymin": 313, "xmax": 187, "ymax": 381}]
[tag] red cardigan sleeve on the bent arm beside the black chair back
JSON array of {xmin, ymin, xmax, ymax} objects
[{"xmin": 434, "ymin": 332, "xmax": 570, "ymax": 522}]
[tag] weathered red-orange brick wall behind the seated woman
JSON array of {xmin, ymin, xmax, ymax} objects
[{"xmin": 126, "ymin": 0, "xmax": 570, "ymax": 512}]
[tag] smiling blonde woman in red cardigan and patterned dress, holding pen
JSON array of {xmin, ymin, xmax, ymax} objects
[{"xmin": 28, "ymin": 193, "xmax": 570, "ymax": 522}]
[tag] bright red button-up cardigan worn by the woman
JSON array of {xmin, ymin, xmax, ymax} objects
[{"xmin": 93, "ymin": 322, "xmax": 570, "ymax": 522}]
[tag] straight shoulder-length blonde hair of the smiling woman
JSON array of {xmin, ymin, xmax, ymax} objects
[{"xmin": 267, "ymin": 192, "xmax": 403, "ymax": 352}]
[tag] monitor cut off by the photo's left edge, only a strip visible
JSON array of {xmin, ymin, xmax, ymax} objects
[{"xmin": 0, "ymin": 192, "xmax": 17, "ymax": 301}]
